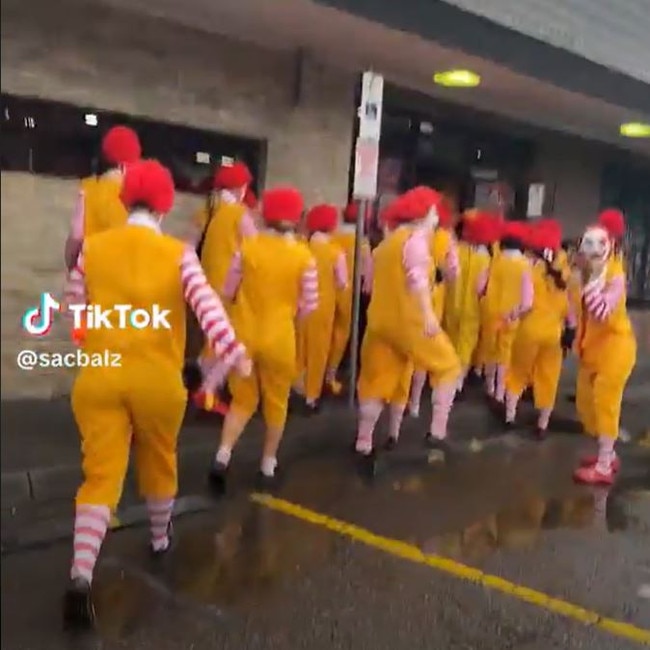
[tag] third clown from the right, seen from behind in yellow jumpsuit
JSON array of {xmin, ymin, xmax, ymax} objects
[{"xmin": 481, "ymin": 221, "xmax": 534, "ymax": 404}]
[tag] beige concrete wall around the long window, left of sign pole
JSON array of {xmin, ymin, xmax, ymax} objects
[{"xmin": 1, "ymin": 0, "xmax": 355, "ymax": 399}]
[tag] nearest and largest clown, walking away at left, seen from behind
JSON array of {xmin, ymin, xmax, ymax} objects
[{"xmin": 63, "ymin": 161, "xmax": 250, "ymax": 627}]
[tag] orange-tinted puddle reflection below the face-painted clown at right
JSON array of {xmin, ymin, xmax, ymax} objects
[{"xmin": 420, "ymin": 466, "xmax": 650, "ymax": 562}]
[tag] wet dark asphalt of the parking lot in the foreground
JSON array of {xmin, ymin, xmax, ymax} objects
[{"xmin": 2, "ymin": 428, "xmax": 650, "ymax": 650}]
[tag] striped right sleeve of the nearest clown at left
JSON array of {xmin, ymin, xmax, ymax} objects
[{"xmin": 181, "ymin": 247, "xmax": 246, "ymax": 367}]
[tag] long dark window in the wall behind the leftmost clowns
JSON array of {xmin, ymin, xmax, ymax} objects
[{"xmin": 2, "ymin": 93, "xmax": 266, "ymax": 193}]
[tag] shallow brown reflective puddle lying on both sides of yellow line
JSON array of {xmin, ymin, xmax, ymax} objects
[{"xmin": 85, "ymin": 444, "xmax": 650, "ymax": 638}]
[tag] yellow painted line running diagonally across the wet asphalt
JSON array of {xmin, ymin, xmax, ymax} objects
[{"xmin": 251, "ymin": 493, "xmax": 650, "ymax": 645}]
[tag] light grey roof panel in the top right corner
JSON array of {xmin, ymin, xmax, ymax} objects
[{"xmin": 445, "ymin": 0, "xmax": 650, "ymax": 82}]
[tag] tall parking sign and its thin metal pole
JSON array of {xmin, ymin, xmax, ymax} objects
[{"xmin": 348, "ymin": 71, "xmax": 384, "ymax": 408}]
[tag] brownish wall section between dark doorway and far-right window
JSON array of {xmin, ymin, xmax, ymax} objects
[{"xmin": 532, "ymin": 136, "xmax": 605, "ymax": 237}]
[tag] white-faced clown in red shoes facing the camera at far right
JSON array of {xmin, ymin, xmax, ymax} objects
[{"xmin": 574, "ymin": 226, "xmax": 637, "ymax": 485}]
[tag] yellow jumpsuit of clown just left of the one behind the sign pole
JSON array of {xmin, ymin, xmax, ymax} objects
[{"xmin": 297, "ymin": 236, "xmax": 345, "ymax": 403}]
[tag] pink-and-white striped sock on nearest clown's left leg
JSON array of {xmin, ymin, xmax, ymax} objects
[{"xmin": 70, "ymin": 504, "xmax": 111, "ymax": 583}]
